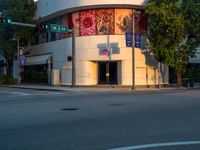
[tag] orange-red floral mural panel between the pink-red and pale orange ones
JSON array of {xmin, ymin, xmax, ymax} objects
[{"xmin": 96, "ymin": 9, "xmax": 115, "ymax": 35}]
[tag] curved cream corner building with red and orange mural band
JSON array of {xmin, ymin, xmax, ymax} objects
[{"xmin": 25, "ymin": 0, "xmax": 168, "ymax": 86}]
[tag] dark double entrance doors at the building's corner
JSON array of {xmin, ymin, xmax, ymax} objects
[{"xmin": 98, "ymin": 62, "xmax": 118, "ymax": 84}]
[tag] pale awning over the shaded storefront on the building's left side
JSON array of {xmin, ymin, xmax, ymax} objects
[{"xmin": 25, "ymin": 55, "xmax": 51, "ymax": 66}]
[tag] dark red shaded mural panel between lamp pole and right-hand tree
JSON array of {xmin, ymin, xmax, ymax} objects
[{"xmin": 134, "ymin": 13, "xmax": 147, "ymax": 35}]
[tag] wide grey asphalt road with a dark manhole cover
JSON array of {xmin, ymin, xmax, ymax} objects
[{"xmin": 0, "ymin": 88, "xmax": 200, "ymax": 150}]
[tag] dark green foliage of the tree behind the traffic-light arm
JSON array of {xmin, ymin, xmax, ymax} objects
[{"xmin": 0, "ymin": 0, "xmax": 36, "ymax": 46}]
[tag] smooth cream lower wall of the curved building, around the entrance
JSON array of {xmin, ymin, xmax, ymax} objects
[{"xmin": 28, "ymin": 35, "xmax": 168, "ymax": 85}]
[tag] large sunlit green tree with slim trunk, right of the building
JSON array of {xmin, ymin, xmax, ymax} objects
[{"xmin": 146, "ymin": 0, "xmax": 200, "ymax": 86}]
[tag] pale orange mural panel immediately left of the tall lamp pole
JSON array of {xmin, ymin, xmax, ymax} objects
[{"xmin": 115, "ymin": 9, "xmax": 133, "ymax": 34}]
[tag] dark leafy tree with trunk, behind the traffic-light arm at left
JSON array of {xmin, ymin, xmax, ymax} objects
[{"xmin": 0, "ymin": 0, "xmax": 36, "ymax": 78}]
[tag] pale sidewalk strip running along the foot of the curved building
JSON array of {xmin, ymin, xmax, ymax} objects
[{"xmin": 1, "ymin": 84, "xmax": 194, "ymax": 93}]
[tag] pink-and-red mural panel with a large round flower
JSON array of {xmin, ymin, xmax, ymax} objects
[{"xmin": 80, "ymin": 10, "xmax": 96, "ymax": 36}]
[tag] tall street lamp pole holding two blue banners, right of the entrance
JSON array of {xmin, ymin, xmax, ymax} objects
[{"xmin": 132, "ymin": 11, "xmax": 141, "ymax": 91}]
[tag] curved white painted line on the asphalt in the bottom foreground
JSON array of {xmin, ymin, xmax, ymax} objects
[{"xmin": 109, "ymin": 141, "xmax": 200, "ymax": 150}]
